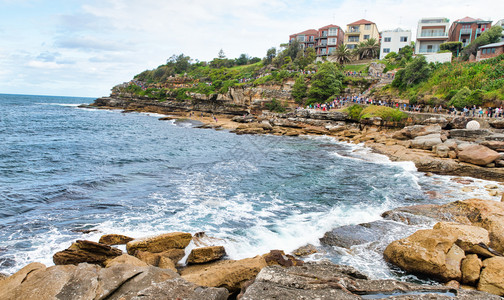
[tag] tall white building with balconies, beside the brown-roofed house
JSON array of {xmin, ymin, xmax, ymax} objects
[{"xmin": 415, "ymin": 18, "xmax": 450, "ymax": 54}]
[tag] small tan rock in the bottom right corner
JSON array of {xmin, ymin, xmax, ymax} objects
[{"xmin": 478, "ymin": 257, "xmax": 504, "ymax": 296}]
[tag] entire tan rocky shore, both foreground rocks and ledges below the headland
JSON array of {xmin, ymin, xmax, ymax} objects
[{"xmin": 0, "ymin": 98, "xmax": 498, "ymax": 299}]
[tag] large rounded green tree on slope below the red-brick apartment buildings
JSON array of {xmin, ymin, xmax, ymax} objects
[{"xmin": 308, "ymin": 62, "xmax": 343, "ymax": 103}]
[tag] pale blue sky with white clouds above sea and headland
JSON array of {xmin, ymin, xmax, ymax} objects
[{"xmin": 0, "ymin": 0, "xmax": 504, "ymax": 97}]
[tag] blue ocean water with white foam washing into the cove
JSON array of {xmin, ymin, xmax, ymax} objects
[{"xmin": 0, "ymin": 94, "xmax": 498, "ymax": 278}]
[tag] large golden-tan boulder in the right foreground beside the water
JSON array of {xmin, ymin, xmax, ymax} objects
[{"xmin": 383, "ymin": 223, "xmax": 488, "ymax": 282}]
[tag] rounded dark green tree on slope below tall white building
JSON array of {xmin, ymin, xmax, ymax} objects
[{"xmin": 392, "ymin": 55, "xmax": 432, "ymax": 89}]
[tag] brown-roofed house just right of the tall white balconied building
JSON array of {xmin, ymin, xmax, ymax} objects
[{"xmin": 448, "ymin": 17, "xmax": 492, "ymax": 47}]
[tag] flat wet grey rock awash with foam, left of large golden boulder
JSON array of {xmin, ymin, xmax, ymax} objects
[{"xmin": 320, "ymin": 220, "xmax": 409, "ymax": 249}]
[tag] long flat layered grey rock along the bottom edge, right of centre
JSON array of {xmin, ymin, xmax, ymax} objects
[{"xmin": 240, "ymin": 262, "xmax": 499, "ymax": 300}]
